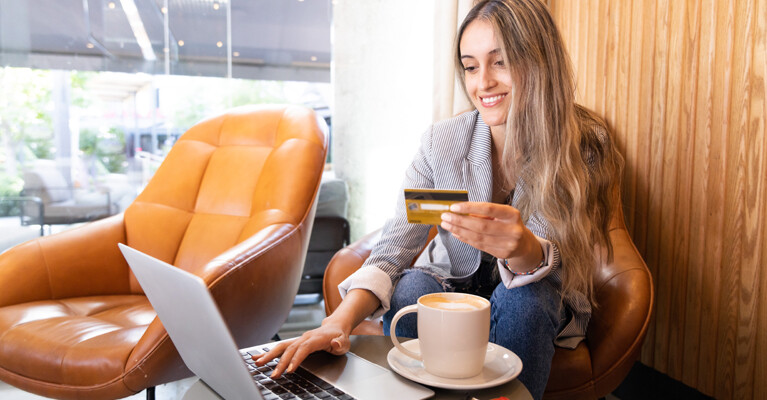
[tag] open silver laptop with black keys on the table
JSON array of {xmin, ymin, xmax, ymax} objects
[{"xmin": 119, "ymin": 243, "xmax": 434, "ymax": 400}]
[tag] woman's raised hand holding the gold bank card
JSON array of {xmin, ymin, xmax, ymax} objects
[{"xmin": 440, "ymin": 202, "xmax": 543, "ymax": 272}]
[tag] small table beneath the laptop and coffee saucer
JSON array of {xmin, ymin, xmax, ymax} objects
[{"xmin": 183, "ymin": 335, "xmax": 533, "ymax": 400}]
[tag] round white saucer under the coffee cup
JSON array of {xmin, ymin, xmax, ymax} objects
[{"xmin": 386, "ymin": 339, "xmax": 522, "ymax": 390}]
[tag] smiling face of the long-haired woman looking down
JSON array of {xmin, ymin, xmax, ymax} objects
[{"xmin": 460, "ymin": 20, "xmax": 512, "ymax": 131}]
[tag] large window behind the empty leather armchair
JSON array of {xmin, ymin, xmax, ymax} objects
[{"xmin": 0, "ymin": 0, "xmax": 331, "ymax": 251}]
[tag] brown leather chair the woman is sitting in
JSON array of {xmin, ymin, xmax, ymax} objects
[{"xmin": 323, "ymin": 205, "xmax": 654, "ymax": 399}]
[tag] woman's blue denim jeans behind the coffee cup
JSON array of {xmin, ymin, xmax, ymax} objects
[{"xmin": 383, "ymin": 270, "xmax": 564, "ymax": 399}]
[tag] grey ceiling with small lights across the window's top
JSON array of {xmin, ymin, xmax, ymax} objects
[{"xmin": 0, "ymin": 0, "xmax": 332, "ymax": 82}]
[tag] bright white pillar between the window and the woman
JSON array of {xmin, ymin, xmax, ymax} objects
[{"xmin": 331, "ymin": 0, "xmax": 439, "ymax": 240}]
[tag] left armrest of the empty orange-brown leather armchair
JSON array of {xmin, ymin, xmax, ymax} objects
[{"xmin": 0, "ymin": 214, "xmax": 130, "ymax": 307}]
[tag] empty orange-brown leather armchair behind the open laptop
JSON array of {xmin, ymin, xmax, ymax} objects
[{"xmin": 0, "ymin": 106, "xmax": 327, "ymax": 399}]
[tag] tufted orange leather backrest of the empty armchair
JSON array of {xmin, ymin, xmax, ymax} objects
[{"xmin": 125, "ymin": 106, "xmax": 326, "ymax": 292}]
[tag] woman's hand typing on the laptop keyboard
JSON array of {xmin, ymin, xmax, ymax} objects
[{"xmin": 253, "ymin": 319, "xmax": 351, "ymax": 378}]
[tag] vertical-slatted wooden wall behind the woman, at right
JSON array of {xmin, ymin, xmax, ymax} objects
[{"xmin": 549, "ymin": 0, "xmax": 767, "ymax": 399}]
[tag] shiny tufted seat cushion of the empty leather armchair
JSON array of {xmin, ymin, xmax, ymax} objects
[{"xmin": 0, "ymin": 295, "xmax": 155, "ymax": 385}]
